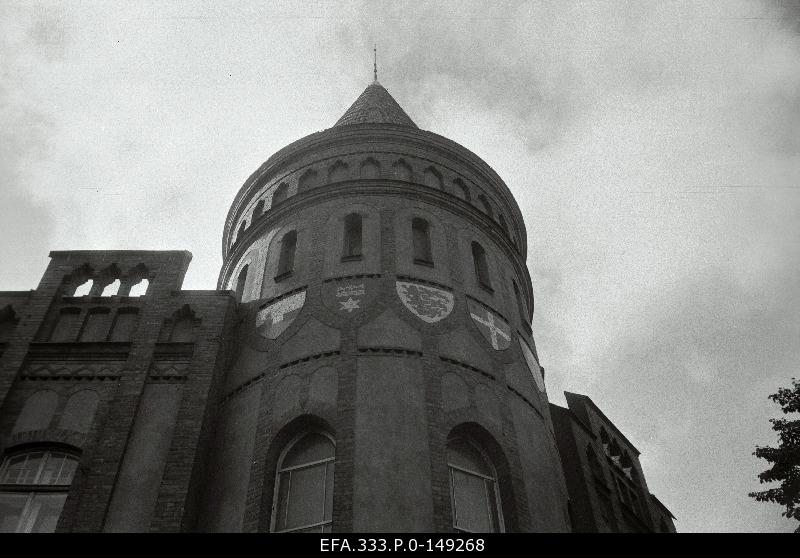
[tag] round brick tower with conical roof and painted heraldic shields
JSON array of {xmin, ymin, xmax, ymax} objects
[{"xmin": 203, "ymin": 80, "xmax": 569, "ymax": 532}]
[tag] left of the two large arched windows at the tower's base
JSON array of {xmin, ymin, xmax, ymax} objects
[{"xmin": 271, "ymin": 432, "xmax": 336, "ymax": 533}]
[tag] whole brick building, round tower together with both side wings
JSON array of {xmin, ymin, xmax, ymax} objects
[{"xmin": 0, "ymin": 80, "xmax": 674, "ymax": 532}]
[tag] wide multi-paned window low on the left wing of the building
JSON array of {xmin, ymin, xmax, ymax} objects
[{"xmin": 0, "ymin": 450, "xmax": 78, "ymax": 533}]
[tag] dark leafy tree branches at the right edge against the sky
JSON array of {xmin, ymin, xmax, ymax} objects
[{"xmin": 748, "ymin": 378, "xmax": 800, "ymax": 533}]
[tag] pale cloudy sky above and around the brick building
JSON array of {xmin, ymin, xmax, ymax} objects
[{"xmin": 0, "ymin": 0, "xmax": 800, "ymax": 531}]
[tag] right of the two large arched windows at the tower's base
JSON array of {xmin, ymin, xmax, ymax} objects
[{"xmin": 447, "ymin": 437, "xmax": 504, "ymax": 533}]
